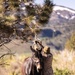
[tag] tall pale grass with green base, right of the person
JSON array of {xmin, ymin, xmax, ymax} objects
[{"xmin": 52, "ymin": 50, "xmax": 75, "ymax": 75}]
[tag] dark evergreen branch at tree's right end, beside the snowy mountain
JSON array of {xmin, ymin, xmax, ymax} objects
[{"xmin": 39, "ymin": 0, "xmax": 53, "ymax": 23}]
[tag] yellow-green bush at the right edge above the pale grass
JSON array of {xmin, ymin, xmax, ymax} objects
[{"xmin": 65, "ymin": 32, "xmax": 75, "ymax": 50}]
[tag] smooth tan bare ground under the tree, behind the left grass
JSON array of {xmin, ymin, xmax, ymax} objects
[{"xmin": 0, "ymin": 39, "xmax": 32, "ymax": 55}]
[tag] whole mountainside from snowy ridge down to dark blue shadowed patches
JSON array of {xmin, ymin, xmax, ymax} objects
[{"xmin": 39, "ymin": 6, "xmax": 75, "ymax": 50}]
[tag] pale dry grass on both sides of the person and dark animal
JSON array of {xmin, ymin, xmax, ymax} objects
[{"xmin": 0, "ymin": 50, "xmax": 75, "ymax": 75}]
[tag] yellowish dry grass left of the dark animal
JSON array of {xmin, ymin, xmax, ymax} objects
[{"xmin": 0, "ymin": 54, "xmax": 31, "ymax": 75}]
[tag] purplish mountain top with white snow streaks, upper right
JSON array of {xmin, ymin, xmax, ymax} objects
[{"xmin": 50, "ymin": 6, "xmax": 75, "ymax": 24}]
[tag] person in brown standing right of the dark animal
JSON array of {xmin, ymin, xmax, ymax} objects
[{"xmin": 35, "ymin": 41, "xmax": 53, "ymax": 75}]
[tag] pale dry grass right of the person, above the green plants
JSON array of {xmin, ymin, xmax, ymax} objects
[{"xmin": 53, "ymin": 50, "xmax": 75, "ymax": 75}]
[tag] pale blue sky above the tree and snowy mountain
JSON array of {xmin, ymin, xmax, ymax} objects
[{"xmin": 35, "ymin": 0, "xmax": 75, "ymax": 9}]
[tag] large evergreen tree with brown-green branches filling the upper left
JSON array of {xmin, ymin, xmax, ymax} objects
[{"xmin": 0, "ymin": 0, "xmax": 53, "ymax": 40}]
